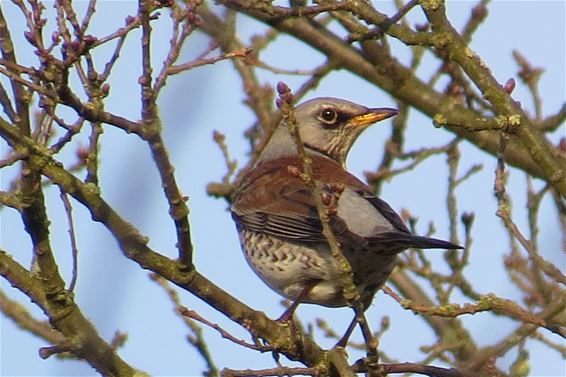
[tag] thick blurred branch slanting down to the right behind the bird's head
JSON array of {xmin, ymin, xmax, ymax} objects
[{"xmin": 221, "ymin": 0, "xmax": 566, "ymax": 194}]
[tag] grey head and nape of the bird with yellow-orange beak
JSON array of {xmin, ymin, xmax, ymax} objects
[{"xmin": 258, "ymin": 97, "xmax": 397, "ymax": 166}]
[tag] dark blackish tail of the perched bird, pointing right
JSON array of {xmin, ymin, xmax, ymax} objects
[{"xmin": 368, "ymin": 232, "xmax": 463, "ymax": 252}]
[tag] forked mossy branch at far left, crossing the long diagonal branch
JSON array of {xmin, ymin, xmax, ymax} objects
[{"xmin": 0, "ymin": 8, "xmax": 98, "ymax": 373}]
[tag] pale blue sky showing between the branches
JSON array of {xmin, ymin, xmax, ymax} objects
[{"xmin": 0, "ymin": 1, "xmax": 566, "ymax": 376}]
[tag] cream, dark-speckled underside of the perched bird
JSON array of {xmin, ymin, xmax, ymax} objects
[{"xmin": 240, "ymin": 230, "xmax": 395, "ymax": 307}]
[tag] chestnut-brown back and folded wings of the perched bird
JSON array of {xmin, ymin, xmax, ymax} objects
[{"xmin": 232, "ymin": 156, "xmax": 410, "ymax": 242}]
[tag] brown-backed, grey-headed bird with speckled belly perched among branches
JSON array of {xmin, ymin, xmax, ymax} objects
[{"xmin": 231, "ymin": 98, "xmax": 461, "ymax": 315}]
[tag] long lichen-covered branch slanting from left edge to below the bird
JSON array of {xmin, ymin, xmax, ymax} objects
[{"xmin": 0, "ymin": 114, "xmax": 332, "ymax": 366}]
